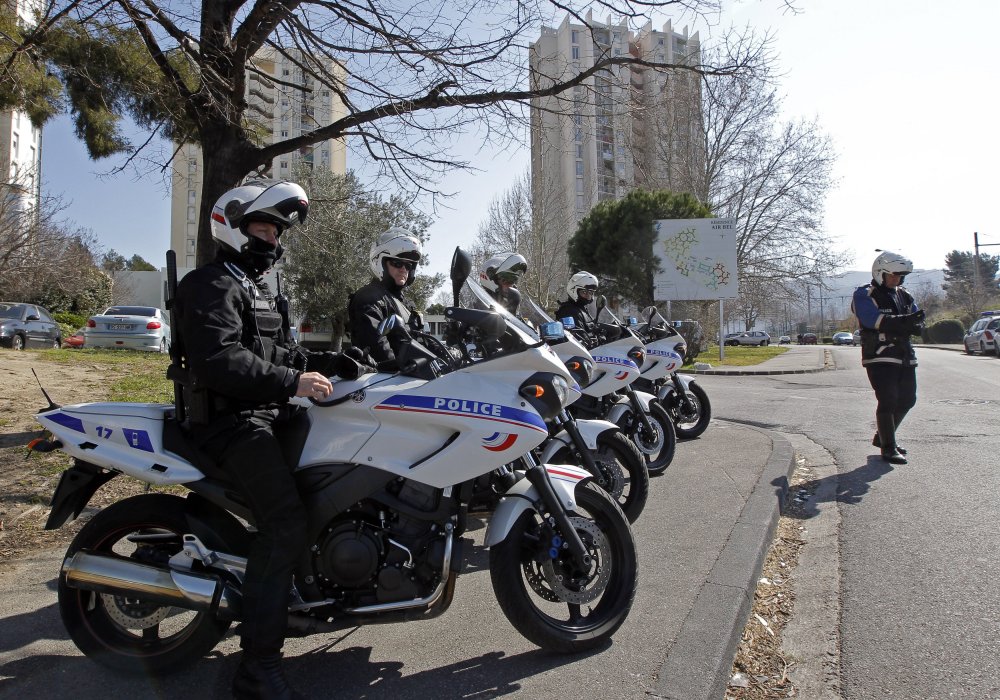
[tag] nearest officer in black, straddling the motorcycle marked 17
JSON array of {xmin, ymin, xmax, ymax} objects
[{"xmin": 174, "ymin": 181, "xmax": 374, "ymax": 698}]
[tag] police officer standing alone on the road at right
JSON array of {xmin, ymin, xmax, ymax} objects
[{"xmin": 851, "ymin": 251, "xmax": 924, "ymax": 464}]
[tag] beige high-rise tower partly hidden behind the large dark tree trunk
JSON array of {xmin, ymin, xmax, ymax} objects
[{"xmin": 170, "ymin": 49, "xmax": 347, "ymax": 268}]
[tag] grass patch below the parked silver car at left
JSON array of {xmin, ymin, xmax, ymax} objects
[{"xmin": 38, "ymin": 348, "xmax": 174, "ymax": 403}]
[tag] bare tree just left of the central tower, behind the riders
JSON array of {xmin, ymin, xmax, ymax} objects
[{"xmin": 475, "ymin": 171, "xmax": 572, "ymax": 307}]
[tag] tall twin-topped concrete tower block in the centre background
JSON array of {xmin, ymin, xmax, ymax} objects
[{"xmin": 529, "ymin": 12, "xmax": 704, "ymax": 237}]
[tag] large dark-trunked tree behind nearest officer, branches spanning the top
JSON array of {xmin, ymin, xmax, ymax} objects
[{"xmin": 0, "ymin": 0, "xmax": 759, "ymax": 263}]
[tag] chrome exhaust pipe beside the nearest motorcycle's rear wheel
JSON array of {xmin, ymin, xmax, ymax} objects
[{"xmin": 62, "ymin": 552, "xmax": 233, "ymax": 610}]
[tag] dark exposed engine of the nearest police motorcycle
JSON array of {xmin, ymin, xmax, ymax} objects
[{"xmin": 312, "ymin": 481, "xmax": 444, "ymax": 607}]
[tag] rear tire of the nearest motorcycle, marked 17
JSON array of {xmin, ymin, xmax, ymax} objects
[{"xmin": 58, "ymin": 494, "xmax": 230, "ymax": 675}]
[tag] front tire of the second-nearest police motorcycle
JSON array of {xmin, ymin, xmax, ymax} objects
[{"xmin": 554, "ymin": 429, "xmax": 649, "ymax": 523}]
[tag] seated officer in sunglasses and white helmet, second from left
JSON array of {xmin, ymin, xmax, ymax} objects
[{"xmin": 347, "ymin": 227, "xmax": 423, "ymax": 363}]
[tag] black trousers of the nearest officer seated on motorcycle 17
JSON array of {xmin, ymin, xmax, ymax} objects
[{"xmin": 192, "ymin": 411, "xmax": 306, "ymax": 655}]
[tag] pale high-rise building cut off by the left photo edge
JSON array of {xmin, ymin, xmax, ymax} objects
[{"xmin": 0, "ymin": 0, "xmax": 42, "ymax": 212}]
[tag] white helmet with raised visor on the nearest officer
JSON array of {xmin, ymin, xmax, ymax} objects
[{"xmin": 211, "ymin": 180, "xmax": 309, "ymax": 274}]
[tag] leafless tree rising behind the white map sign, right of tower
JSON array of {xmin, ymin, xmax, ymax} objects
[{"xmin": 637, "ymin": 38, "xmax": 848, "ymax": 296}]
